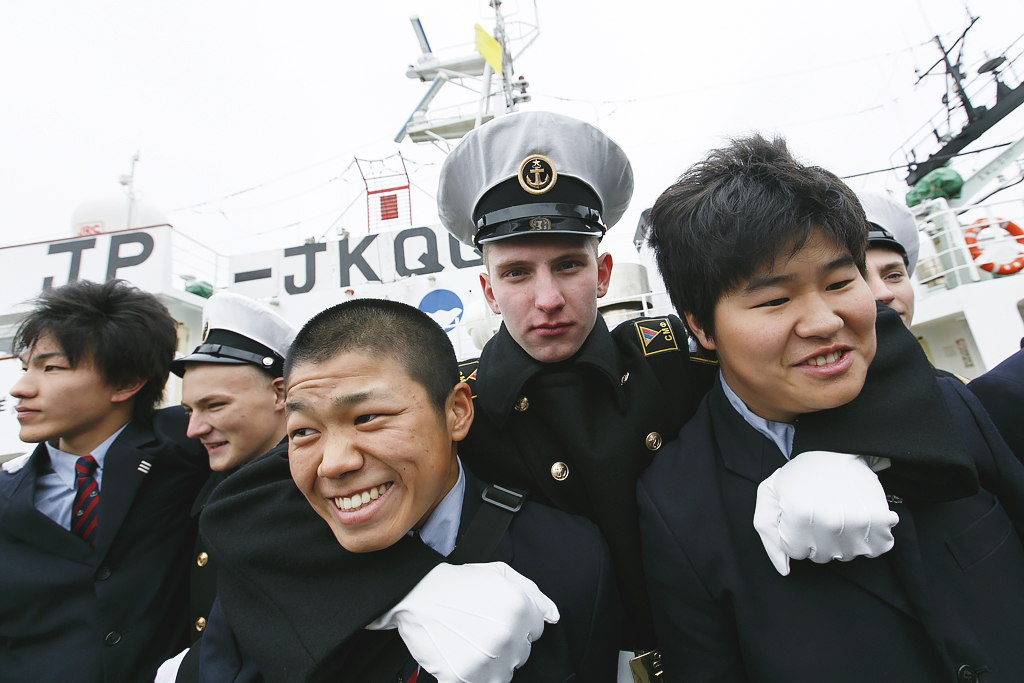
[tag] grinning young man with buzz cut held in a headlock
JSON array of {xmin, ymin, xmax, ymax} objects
[{"xmin": 201, "ymin": 299, "xmax": 618, "ymax": 683}]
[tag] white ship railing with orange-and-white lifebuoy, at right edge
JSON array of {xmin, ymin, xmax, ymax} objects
[{"xmin": 914, "ymin": 194, "xmax": 1024, "ymax": 297}]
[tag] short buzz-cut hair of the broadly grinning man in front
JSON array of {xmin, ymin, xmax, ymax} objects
[{"xmin": 285, "ymin": 299, "xmax": 460, "ymax": 416}]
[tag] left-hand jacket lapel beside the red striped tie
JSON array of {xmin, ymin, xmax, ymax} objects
[{"xmin": 0, "ymin": 443, "xmax": 94, "ymax": 564}]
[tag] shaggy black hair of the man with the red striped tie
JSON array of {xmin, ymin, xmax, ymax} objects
[{"xmin": 13, "ymin": 280, "xmax": 177, "ymax": 422}]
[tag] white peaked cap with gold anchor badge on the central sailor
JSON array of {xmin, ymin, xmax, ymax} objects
[{"xmin": 437, "ymin": 112, "xmax": 633, "ymax": 246}]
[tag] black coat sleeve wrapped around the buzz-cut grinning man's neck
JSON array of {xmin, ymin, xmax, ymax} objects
[{"xmin": 200, "ymin": 444, "xmax": 443, "ymax": 683}]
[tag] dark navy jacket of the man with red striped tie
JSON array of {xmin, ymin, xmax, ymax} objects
[{"xmin": 0, "ymin": 408, "xmax": 209, "ymax": 683}]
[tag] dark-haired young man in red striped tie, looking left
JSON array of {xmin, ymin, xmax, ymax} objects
[{"xmin": 0, "ymin": 281, "xmax": 209, "ymax": 683}]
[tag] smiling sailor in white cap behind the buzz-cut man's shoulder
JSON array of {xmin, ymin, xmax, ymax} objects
[{"xmin": 158, "ymin": 292, "xmax": 296, "ymax": 682}]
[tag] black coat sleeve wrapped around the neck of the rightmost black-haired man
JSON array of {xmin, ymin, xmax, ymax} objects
[{"xmin": 793, "ymin": 304, "xmax": 978, "ymax": 501}]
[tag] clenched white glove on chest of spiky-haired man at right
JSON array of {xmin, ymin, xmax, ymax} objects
[{"xmin": 754, "ymin": 451, "xmax": 899, "ymax": 577}]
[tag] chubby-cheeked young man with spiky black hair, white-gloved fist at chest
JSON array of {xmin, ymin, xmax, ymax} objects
[{"xmin": 637, "ymin": 135, "xmax": 1024, "ymax": 683}]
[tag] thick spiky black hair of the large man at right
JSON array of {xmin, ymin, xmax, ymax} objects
[{"xmin": 648, "ymin": 134, "xmax": 867, "ymax": 338}]
